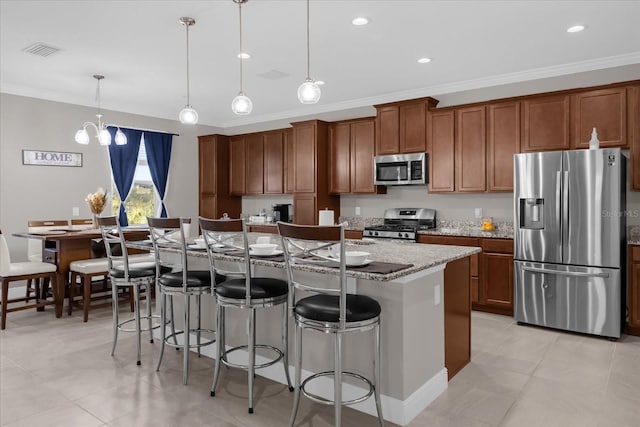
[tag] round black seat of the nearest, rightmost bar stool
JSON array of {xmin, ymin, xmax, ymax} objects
[{"xmin": 294, "ymin": 294, "xmax": 381, "ymax": 323}]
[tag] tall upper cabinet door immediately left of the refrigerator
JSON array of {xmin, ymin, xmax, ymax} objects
[{"xmin": 487, "ymin": 102, "xmax": 520, "ymax": 191}]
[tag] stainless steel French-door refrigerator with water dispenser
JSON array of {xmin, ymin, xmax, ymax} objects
[{"xmin": 514, "ymin": 148, "xmax": 626, "ymax": 338}]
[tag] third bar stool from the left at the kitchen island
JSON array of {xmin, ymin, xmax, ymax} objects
[{"xmin": 200, "ymin": 218, "xmax": 293, "ymax": 414}]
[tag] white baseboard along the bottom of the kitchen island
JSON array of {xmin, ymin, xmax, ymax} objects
[{"xmin": 156, "ymin": 330, "xmax": 448, "ymax": 426}]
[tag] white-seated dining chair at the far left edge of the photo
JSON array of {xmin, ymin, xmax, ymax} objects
[{"xmin": 0, "ymin": 230, "xmax": 56, "ymax": 329}]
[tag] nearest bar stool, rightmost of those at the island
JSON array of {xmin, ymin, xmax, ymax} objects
[{"xmin": 278, "ymin": 222, "xmax": 384, "ymax": 427}]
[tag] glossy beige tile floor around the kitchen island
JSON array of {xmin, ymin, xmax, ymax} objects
[{"xmin": 0, "ymin": 308, "xmax": 640, "ymax": 427}]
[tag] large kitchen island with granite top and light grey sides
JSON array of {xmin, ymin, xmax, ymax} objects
[{"xmin": 148, "ymin": 239, "xmax": 480, "ymax": 425}]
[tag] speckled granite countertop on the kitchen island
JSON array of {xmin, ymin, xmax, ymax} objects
[{"xmin": 127, "ymin": 239, "xmax": 481, "ymax": 281}]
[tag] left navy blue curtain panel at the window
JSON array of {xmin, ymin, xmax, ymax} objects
[{"xmin": 107, "ymin": 126, "xmax": 142, "ymax": 227}]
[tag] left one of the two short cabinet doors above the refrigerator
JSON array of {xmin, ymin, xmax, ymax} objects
[{"xmin": 520, "ymin": 95, "xmax": 571, "ymax": 153}]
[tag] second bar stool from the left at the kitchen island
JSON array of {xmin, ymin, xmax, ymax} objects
[{"xmin": 147, "ymin": 217, "xmax": 215, "ymax": 385}]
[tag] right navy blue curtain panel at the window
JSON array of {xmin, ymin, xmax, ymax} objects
[{"xmin": 144, "ymin": 131, "xmax": 173, "ymax": 218}]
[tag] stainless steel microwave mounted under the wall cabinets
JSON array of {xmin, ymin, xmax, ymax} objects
[{"xmin": 373, "ymin": 153, "xmax": 427, "ymax": 185}]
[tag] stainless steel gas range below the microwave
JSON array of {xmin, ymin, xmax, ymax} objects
[{"xmin": 363, "ymin": 208, "xmax": 436, "ymax": 241}]
